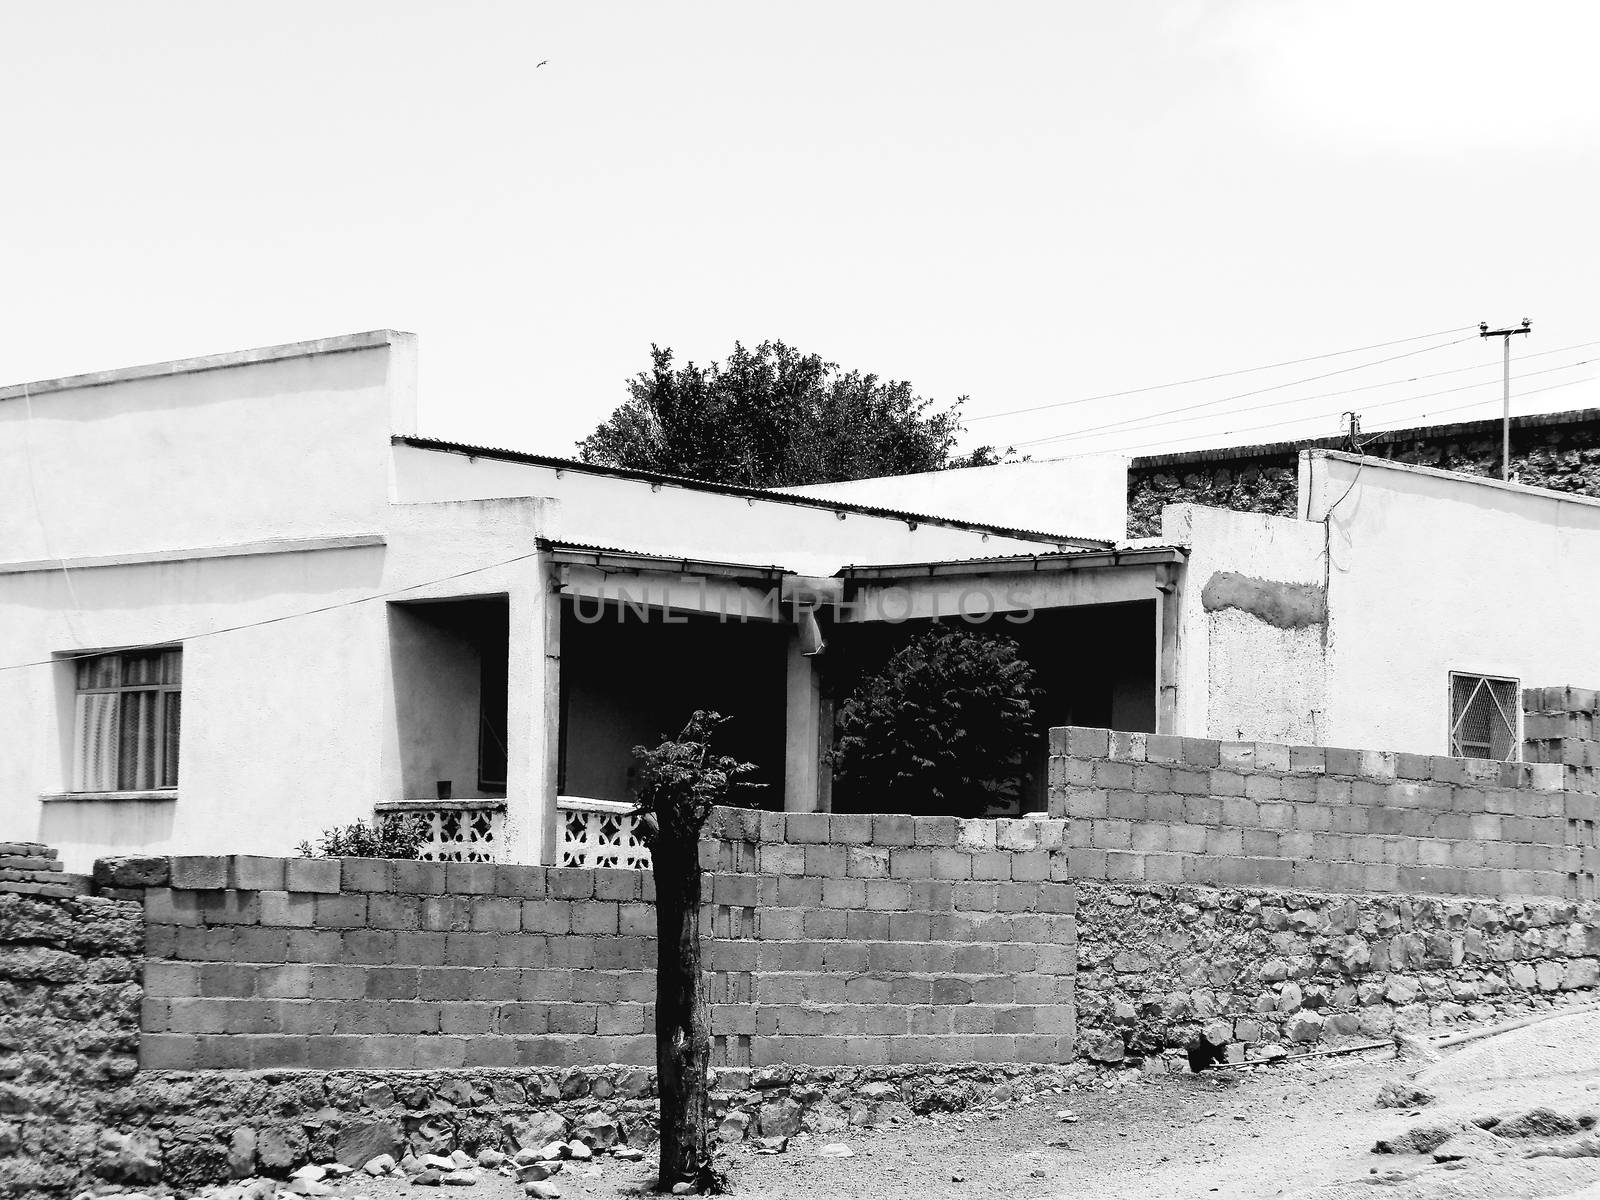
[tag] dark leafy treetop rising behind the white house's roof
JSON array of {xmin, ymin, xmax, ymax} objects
[{"xmin": 578, "ymin": 341, "xmax": 1000, "ymax": 488}]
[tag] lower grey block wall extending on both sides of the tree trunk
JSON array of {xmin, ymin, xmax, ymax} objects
[{"xmin": 141, "ymin": 810, "xmax": 1075, "ymax": 1070}]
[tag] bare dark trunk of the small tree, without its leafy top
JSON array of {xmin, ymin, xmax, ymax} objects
[{"xmin": 651, "ymin": 830, "xmax": 722, "ymax": 1192}]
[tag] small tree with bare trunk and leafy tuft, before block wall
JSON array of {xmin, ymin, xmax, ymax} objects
[{"xmin": 634, "ymin": 710, "xmax": 755, "ymax": 1192}]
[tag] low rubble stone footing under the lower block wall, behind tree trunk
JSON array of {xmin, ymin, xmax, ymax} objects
[{"xmin": 103, "ymin": 1064, "xmax": 1075, "ymax": 1195}]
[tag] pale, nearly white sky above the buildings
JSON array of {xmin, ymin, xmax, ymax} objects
[{"xmin": 0, "ymin": 0, "xmax": 1600, "ymax": 458}]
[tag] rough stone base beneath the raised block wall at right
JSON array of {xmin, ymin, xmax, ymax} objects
[{"xmin": 1077, "ymin": 883, "xmax": 1600, "ymax": 1064}]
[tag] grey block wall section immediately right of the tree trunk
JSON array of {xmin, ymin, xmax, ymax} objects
[{"xmin": 707, "ymin": 810, "xmax": 1077, "ymax": 1067}]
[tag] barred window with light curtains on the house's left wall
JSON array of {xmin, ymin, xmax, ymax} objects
[{"xmin": 72, "ymin": 650, "xmax": 182, "ymax": 792}]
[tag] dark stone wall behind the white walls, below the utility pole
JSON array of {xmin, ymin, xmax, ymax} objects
[{"xmin": 1128, "ymin": 410, "xmax": 1600, "ymax": 538}]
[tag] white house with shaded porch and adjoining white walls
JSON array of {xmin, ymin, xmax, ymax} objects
[{"xmin": 0, "ymin": 331, "xmax": 1600, "ymax": 869}]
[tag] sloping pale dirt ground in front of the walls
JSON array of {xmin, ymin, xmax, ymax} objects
[{"xmin": 187, "ymin": 1014, "xmax": 1600, "ymax": 1200}]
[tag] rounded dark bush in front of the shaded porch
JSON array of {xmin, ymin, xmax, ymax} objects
[{"xmin": 834, "ymin": 624, "xmax": 1038, "ymax": 814}]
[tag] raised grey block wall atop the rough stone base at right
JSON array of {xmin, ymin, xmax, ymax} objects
[{"xmin": 1050, "ymin": 728, "xmax": 1597, "ymax": 898}]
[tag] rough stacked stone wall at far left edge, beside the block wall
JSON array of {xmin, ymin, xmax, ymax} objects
[{"xmin": 0, "ymin": 843, "xmax": 149, "ymax": 1197}]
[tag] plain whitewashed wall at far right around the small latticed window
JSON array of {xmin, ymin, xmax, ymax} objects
[{"xmin": 1301, "ymin": 451, "xmax": 1600, "ymax": 754}]
